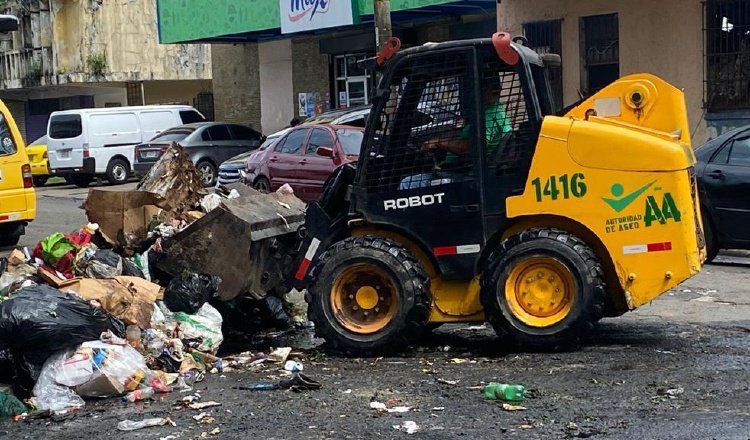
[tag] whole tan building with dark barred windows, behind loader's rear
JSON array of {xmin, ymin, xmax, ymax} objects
[{"xmin": 498, "ymin": 0, "xmax": 750, "ymax": 146}]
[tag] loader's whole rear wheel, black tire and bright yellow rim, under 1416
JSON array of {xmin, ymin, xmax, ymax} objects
[{"xmin": 481, "ymin": 229, "xmax": 605, "ymax": 350}]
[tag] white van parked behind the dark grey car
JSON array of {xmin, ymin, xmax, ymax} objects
[{"xmin": 47, "ymin": 105, "xmax": 206, "ymax": 188}]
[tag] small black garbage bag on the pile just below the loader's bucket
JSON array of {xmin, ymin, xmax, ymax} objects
[{"xmin": 164, "ymin": 273, "xmax": 221, "ymax": 315}]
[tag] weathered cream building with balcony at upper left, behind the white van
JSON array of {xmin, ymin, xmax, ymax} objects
[{"xmin": 0, "ymin": 0, "xmax": 213, "ymax": 142}]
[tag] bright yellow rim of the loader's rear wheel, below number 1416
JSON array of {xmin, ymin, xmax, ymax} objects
[{"xmin": 505, "ymin": 257, "xmax": 576, "ymax": 327}]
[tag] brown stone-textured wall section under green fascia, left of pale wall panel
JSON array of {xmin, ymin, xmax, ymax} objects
[{"xmin": 211, "ymin": 43, "xmax": 261, "ymax": 130}]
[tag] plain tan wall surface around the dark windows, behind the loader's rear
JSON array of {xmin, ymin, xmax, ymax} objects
[{"xmin": 498, "ymin": 0, "xmax": 713, "ymax": 146}]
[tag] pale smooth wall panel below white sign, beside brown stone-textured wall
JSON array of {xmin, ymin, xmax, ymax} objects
[{"xmin": 258, "ymin": 40, "xmax": 296, "ymax": 134}]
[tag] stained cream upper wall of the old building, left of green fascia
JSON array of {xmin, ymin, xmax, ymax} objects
[{"xmin": 50, "ymin": 0, "xmax": 211, "ymax": 82}]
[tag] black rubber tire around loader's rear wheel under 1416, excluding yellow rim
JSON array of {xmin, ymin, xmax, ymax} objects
[{"xmin": 481, "ymin": 229, "xmax": 606, "ymax": 350}]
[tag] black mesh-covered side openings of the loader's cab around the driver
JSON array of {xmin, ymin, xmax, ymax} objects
[{"xmin": 364, "ymin": 47, "xmax": 531, "ymax": 193}]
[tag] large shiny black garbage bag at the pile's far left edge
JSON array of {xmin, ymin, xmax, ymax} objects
[{"xmin": 0, "ymin": 285, "xmax": 125, "ymax": 397}]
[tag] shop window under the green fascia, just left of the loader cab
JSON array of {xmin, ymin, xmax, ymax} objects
[{"xmin": 333, "ymin": 54, "xmax": 373, "ymax": 108}]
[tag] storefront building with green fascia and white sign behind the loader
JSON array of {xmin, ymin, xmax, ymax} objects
[{"xmin": 157, "ymin": 0, "xmax": 497, "ymax": 133}]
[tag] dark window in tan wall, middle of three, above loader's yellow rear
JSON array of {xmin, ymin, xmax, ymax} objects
[{"xmin": 580, "ymin": 14, "xmax": 620, "ymax": 96}]
